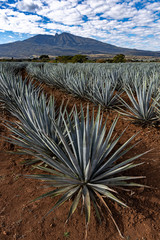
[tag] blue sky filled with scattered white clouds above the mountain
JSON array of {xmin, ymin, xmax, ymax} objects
[{"xmin": 0, "ymin": 0, "xmax": 160, "ymax": 51}]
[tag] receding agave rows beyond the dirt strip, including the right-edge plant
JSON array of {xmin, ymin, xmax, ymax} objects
[{"xmin": 26, "ymin": 64, "xmax": 160, "ymax": 124}]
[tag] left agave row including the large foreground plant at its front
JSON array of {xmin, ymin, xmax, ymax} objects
[{"xmin": 0, "ymin": 67, "xmax": 150, "ymax": 237}]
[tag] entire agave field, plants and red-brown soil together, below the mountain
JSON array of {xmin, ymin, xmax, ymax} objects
[{"xmin": 0, "ymin": 62, "xmax": 160, "ymax": 240}]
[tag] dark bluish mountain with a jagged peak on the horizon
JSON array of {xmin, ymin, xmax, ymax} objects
[{"xmin": 0, "ymin": 33, "xmax": 160, "ymax": 58}]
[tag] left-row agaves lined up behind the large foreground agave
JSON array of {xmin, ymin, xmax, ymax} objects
[{"xmin": 0, "ymin": 71, "xmax": 71, "ymax": 164}]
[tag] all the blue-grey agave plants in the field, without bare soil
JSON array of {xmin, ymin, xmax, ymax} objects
[{"xmin": 0, "ymin": 63, "xmax": 160, "ymax": 240}]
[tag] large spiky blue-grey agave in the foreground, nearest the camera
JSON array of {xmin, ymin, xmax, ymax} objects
[{"xmin": 24, "ymin": 107, "xmax": 147, "ymax": 237}]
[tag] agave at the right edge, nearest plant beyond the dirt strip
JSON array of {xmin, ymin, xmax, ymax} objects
[{"xmin": 120, "ymin": 82, "xmax": 158, "ymax": 124}]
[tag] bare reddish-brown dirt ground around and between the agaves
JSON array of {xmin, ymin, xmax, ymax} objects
[{"xmin": 0, "ymin": 85, "xmax": 160, "ymax": 240}]
